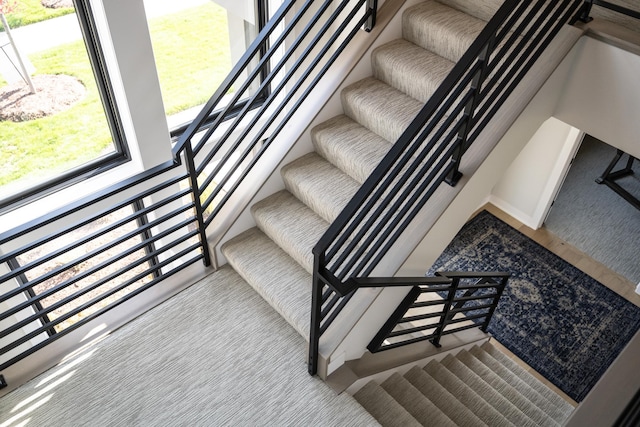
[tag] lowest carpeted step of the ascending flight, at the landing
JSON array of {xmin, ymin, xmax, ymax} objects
[{"xmin": 221, "ymin": 227, "xmax": 312, "ymax": 341}]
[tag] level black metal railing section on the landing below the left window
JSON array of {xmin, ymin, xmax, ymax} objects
[{"xmin": 0, "ymin": 162, "xmax": 206, "ymax": 371}]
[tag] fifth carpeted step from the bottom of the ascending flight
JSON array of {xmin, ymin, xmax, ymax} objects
[{"xmin": 341, "ymin": 77, "xmax": 424, "ymax": 143}]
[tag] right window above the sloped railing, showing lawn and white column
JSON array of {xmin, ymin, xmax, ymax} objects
[{"xmin": 145, "ymin": 0, "xmax": 267, "ymax": 136}]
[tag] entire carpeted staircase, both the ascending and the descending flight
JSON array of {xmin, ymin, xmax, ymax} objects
[{"xmin": 222, "ymin": 0, "xmax": 573, "ymax": 426}]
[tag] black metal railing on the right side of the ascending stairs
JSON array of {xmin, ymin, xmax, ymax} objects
[{"xmin": 309, "ymin": 0, "xmax": 582, "ymax": 374}]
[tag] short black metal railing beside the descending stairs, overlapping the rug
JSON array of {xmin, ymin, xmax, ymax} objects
[{"xmin": 358, "ymin": 272, "xmax": 509, "ymax": 353}]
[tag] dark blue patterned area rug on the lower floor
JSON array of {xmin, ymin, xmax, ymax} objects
[{"xmin": 428, "ymin": 211, "xmax": 640, "ymax": 402}]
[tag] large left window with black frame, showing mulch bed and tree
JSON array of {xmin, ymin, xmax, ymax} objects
[{"xmin": 0, "ymin": 0, "xmax": 129, "ymax": 210}]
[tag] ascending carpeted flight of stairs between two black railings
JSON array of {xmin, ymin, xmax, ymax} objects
[{"xmin": 222, "ymin": 0, "xmax": 500, "ymax": 340}]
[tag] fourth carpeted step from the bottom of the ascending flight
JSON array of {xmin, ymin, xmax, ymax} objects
[{"xmin": 311, "ymin": 114, "xmax": 392, "ymax": 184}]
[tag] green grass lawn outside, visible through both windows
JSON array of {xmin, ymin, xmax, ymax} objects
[{"xmin": 0, "ymin": 0, "xmax": 230, "ymax": 190}]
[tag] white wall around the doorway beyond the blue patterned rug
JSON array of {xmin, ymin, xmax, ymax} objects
[{"xmin": 489, "ymin": 37, "xmax": 640, "ymax": 229}]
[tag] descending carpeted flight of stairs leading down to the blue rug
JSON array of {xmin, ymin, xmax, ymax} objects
[{"xmin": 354, "ymin": 342, "xmax": 573, "ymax": 427}]
